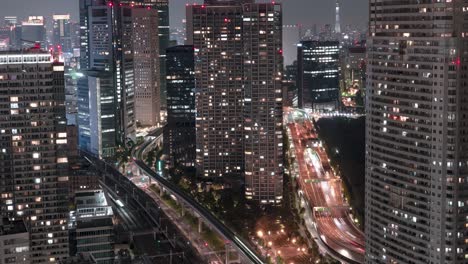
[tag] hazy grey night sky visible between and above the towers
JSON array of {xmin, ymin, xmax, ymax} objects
[{"xmin": 0, "ymin": 0, "xmax": 368, "ymax": 63}]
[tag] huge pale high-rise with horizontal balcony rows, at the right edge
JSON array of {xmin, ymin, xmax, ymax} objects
[{"xmin": 365, "ymin": 0, "xmax": 468, "ymax": 263}]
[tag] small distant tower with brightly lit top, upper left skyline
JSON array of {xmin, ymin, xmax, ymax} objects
[{"xmin": 52, "ymin": 15, "xmax": 73, "ymax": 53}]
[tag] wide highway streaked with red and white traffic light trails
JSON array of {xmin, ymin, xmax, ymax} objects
[{"xmin": 286, "ymin": 109, "xmax": 364, "ymax": 263}]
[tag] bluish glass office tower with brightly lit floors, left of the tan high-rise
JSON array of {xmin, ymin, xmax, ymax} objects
[{"xmin": 78, "ymin": 0, "xmax": 135, "ymax": 157}]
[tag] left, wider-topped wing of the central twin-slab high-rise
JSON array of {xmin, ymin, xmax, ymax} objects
[{"xmin": 187, "ymin": 0, "xmax": 244, "ymax": 177}]
